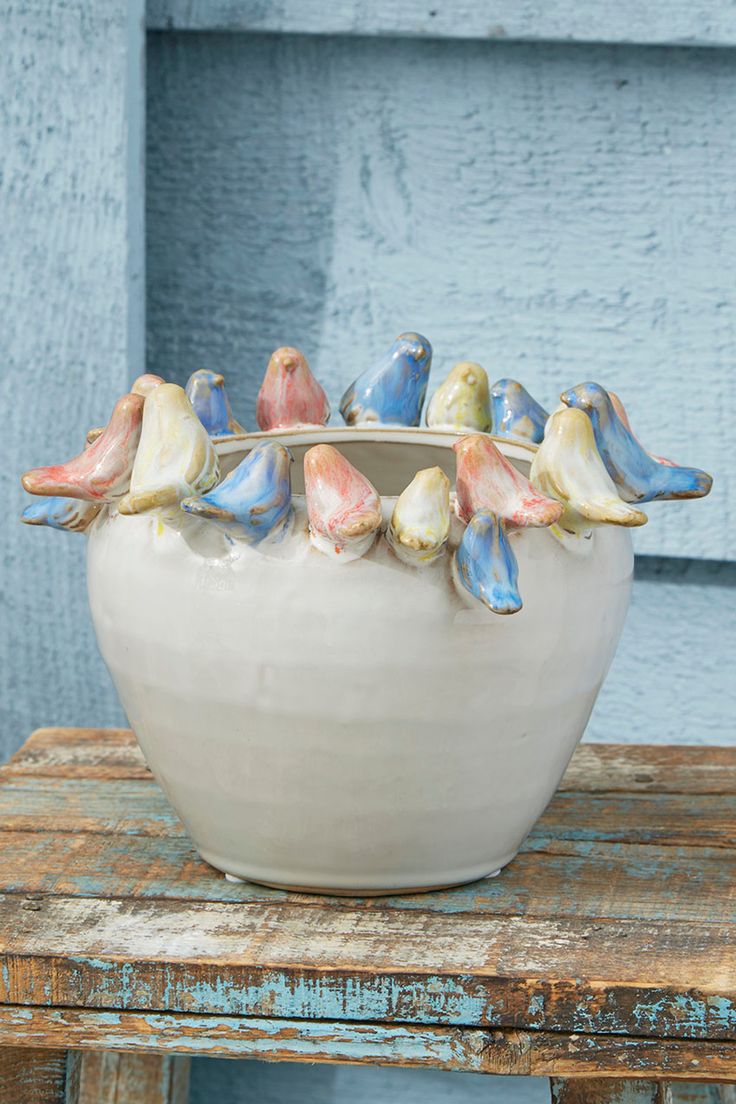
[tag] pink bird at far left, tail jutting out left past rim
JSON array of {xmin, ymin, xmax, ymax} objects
[{"xmin": 22, "ymin": 394, "xmax": 143, "ymax": 502}]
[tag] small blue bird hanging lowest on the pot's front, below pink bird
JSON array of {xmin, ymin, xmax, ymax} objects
[{"xmin": 454, "ymin": 510, "xmax": 522, "ymax": 614}]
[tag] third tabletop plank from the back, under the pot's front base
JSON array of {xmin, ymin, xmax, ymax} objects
[{"xmin": 0, "ymin": 830, "xmax": 736, "ymax": 924}]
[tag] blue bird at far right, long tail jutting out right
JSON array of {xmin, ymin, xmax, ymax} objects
[{"xmin": 561, "ymin": 383, "xmax": 713, "ymax": 502}]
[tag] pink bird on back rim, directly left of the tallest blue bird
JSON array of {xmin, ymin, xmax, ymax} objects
[{"xmin": 256, "ymin": 346, "xmax": 330, "ymax": 429}]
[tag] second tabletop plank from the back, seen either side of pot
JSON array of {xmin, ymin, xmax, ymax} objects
[{"xmin": 0, "ymin": 774, "xmax": 736, "ymax": 848}]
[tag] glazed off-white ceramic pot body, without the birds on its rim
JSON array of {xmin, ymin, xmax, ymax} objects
[{"xmin": 88, "ymin": 428, "xmax": 633, "ymax": 893}]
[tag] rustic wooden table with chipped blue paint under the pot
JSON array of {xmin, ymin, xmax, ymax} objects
[{"xmin": 0, "ymin": 729, "xmax": 736, "ymax": 1104}]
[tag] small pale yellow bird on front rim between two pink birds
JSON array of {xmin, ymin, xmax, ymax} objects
[{"xmin": 386, "ymin": 468, "xmax": 450, "ymax": 566}]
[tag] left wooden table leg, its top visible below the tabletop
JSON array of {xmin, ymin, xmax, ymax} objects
[{"xmin": 68, "ymin": 1051, "xmax": 190, "ymax": 1104}]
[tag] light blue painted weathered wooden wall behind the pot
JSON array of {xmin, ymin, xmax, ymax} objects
[{"xmin": 0, "ymin": 0, "xmax": 736, "ymax": 1104}]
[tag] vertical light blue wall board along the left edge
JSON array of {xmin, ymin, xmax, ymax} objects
[{"xmin": 0, "ymin": 0, "xmax": 143, "ymax": 755}]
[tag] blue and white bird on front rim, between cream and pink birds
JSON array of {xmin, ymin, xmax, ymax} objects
[{"xmin": 181, "ymin": 440, "xmax": 292, "ymax": 544}]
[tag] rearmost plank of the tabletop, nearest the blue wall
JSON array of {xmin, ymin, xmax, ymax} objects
[{"xmin": 5, "ymin": 728, "xmax": 736, "ymax": 794}]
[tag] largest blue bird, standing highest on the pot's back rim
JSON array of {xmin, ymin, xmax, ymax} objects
[{"xmin": 340, "ymin": 333, "xmax": 431, "ymax": 425}]
